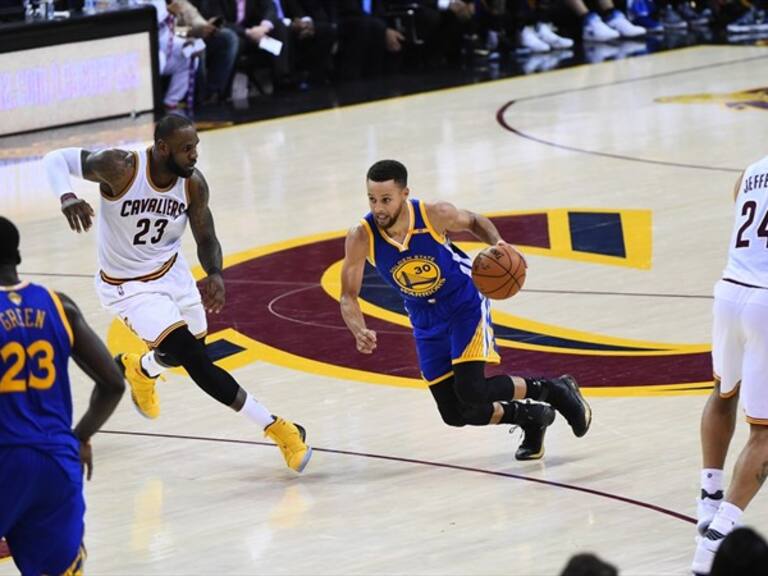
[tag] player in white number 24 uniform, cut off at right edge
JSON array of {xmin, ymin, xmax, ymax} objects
[{"xmin": 692, "ymin": 157, "xmax": 768, "ymax": 574}]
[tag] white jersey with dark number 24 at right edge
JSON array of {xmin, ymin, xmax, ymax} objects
[{"xmin": 723, "ymin": 156, "xmax": 768, "ymax": 288}]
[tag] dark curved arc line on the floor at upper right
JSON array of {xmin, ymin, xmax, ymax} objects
[{"xmin": 496, "ymin": 56, "xmax": 768, "ymax": 174}]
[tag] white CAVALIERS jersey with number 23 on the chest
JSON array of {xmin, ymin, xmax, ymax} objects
[{"xmin": 97, "ymin": 149, "xmax": 189, "ymax": 284}]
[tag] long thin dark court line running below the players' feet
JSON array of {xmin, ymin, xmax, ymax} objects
[{"xmin": 101, "ymin": 430, "xmax": 696, "ymax": 524}]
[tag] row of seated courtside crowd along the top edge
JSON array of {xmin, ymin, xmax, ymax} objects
[{"xmin": 130, "ymin": 0, "xmax": 768, "ymax": 109}]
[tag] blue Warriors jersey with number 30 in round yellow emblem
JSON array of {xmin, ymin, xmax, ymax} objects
[{"xmin": 362, "ymin": 199, "xmax": 479, "ymax": 310}]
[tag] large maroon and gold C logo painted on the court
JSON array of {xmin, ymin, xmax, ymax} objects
[{"xmin": 109, "ymin": 209, "xmax": 712, "ymax": 396}]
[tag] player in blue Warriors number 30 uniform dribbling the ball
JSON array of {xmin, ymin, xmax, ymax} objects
[{"xmin": 341, "ymin": 160, "xmax": 592, "ymax": 460}]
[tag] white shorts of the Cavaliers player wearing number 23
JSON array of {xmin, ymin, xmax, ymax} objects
[{"xmin": 95, "ymin": 253, "xmax": 208, "ymax": 348}]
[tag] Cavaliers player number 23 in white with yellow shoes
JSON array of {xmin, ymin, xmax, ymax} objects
[{"xmin": 44, "ymin": 115, "xmax": 312, "ymax": 472}]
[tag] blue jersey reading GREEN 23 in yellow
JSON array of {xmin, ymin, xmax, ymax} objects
[{"xmin": 0, "ymin": 283, "xmax": 79, "ymax": 457}]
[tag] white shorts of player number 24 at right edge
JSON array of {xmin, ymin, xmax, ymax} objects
[{"xmin": 712, "ymin": 280, "xmax": 768, "ymax": 426}]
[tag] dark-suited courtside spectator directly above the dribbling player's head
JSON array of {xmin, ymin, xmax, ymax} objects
[{"xmin": 338, "ymin": 0, "xmax": 405, "ymax": 80}]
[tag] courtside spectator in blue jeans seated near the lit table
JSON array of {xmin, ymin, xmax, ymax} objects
[{"xmin": 168, "ymin": 0, "xmax": 240, "ymax": 102}]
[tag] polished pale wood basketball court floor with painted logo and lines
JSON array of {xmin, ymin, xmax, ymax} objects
[{"xmin": 0, "ymin": 47, "xmax": 768, "ymax": 576}]
